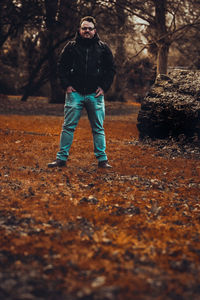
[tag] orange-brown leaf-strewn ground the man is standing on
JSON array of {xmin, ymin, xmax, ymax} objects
[{"xmin": 0, "ymin": 99, "xmax": 200, "ymax": 300}]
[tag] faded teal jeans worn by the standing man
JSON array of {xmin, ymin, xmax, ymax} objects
[{"xmin": 56, "ymin": 92, "xmax": 107, "ymax": 162}]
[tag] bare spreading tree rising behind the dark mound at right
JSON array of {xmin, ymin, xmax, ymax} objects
[{"xmin": 103, "ymin": 0, "xmax": 200, "ymax": 74}]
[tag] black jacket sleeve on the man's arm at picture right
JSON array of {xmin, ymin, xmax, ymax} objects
[{"xmin": 100, "ymin": 43, "xmax": 116, "ymax": 92}]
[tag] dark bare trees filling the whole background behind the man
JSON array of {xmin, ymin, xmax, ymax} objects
[{"xmin": 0, "ymin": 0, "xmax": 200, "ymax": 102}]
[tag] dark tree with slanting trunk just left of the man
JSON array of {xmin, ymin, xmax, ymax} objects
[{"xmin": 21, "ymin": 0, "xmax": 76, "ymax": 103}]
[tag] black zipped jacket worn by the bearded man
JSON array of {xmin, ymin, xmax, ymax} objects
[{"xmin": 58, "ymin": 33, "xmax": 115, "ymax": 95}]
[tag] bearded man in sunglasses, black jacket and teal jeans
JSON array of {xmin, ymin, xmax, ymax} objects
[{"xmin": 48, "ymin": 16, "xmax": 115, "ymax": 168}]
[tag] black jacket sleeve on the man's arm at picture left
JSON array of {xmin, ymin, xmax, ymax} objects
[{"xmin": 57, "ymin": 42, "xmax": 73, "ymax": 90}]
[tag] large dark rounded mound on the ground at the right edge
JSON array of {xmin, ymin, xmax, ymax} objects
[{"xmin": 137, "ymin": 69, "xmax": 200, "ymax": 140}]
